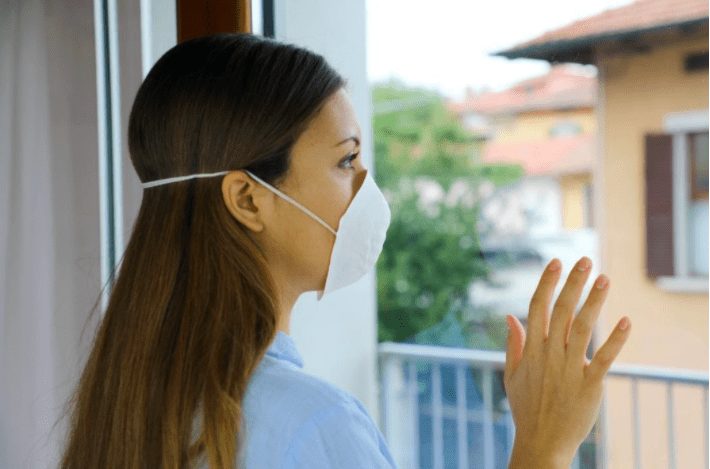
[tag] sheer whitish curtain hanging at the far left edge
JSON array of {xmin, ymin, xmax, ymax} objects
[{"xmin": 0, "ymin": 0, "xmax": 100, "ymax": 469}]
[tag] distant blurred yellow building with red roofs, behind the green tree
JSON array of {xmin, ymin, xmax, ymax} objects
[{"xmin": 448, "ymin": 65, "xmax": 597, "ymax": 230}]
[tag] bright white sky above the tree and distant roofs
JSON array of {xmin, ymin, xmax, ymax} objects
[{"xmin": 366, "ymin": 0, "xmax": 631, "ymax": 99}]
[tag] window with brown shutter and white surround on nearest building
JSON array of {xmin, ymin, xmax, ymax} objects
[{"xmin": 645, "ymin": 110, "xmax": 708, "ymax": 292}]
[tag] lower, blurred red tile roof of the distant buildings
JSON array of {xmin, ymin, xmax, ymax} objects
[{"xmin": 483, "ymin": 134, "xmax": 596, "ymax": 176}]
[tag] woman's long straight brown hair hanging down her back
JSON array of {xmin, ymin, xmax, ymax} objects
[{"xmin": 61, "ymin": 33, "xmax": 347, "ymax": 469}]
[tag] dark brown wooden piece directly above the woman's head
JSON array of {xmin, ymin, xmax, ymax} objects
[{"xmin": 177, "ymin": 0, "xmax": 251, "ymax": 42}]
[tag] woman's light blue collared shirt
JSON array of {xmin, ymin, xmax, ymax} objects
[{"xmin": 240, "ymin": 331, "xmax": 396, "ymax": 469}]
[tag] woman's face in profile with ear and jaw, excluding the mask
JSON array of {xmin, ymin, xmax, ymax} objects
[{"xmin": 223, "ymin": 88, "xmax": 366, "ymax": 296}]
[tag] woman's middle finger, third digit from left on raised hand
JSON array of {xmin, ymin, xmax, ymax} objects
[{"xmin": 548, "ymin": 256, "xmax": 592, "ymax": 353}]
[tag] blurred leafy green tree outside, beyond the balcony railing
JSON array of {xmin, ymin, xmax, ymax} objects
[{"xmin": 372, "ymin": 81, "xmax": 522, "ymax": 341}]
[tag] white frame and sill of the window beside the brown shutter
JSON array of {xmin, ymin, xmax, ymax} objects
[{"xmin": 656, "ymin": 109, "xmax": 708, "ymax": 293}]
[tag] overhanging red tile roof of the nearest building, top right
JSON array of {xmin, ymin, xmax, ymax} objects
[{"xmin": 493, "ymin": 0, "xmax": 708, "ymax": 63}]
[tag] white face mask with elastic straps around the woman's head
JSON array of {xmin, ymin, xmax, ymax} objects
[{"xmin": 143, "ymin": 170, "xmax": 391, "ymax": 301}]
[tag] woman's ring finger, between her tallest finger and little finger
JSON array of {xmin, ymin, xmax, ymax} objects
[{"xmin": 567, "ymin": 274, "xmax": 609, "ymax": 367}]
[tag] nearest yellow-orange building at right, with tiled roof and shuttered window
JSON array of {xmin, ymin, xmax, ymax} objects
[{"xmin": 497, "ymin": 0, "xmax": 708, "ymax": 469}]
